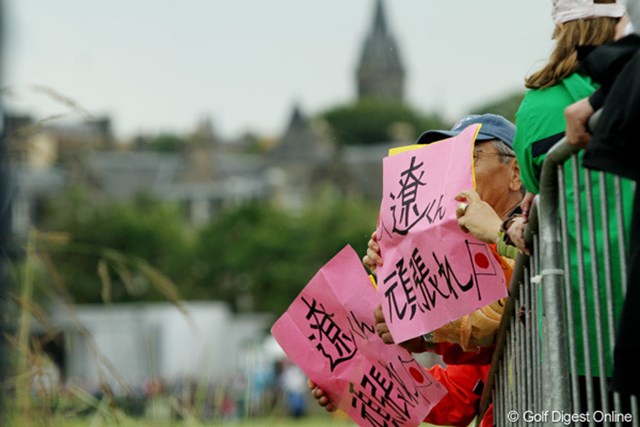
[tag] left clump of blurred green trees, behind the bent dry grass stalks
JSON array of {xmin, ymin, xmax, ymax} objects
[{"xmin": 35, "ymin": 187, "xmax": 191, "ymax": 303}]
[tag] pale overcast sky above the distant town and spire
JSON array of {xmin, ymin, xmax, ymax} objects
[{"xmin": 3, "ymin": 0, "xmax": 553, "ymax": 138}]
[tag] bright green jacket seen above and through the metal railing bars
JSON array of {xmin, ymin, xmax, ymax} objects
[{"xmin": 514, "ymin": 73, "xmax": 634, "ymax": 376}]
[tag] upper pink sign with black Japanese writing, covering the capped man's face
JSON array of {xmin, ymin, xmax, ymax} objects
[{"xmin": 377, "ymin": 125, "xmax": 507, "ymax": 342}]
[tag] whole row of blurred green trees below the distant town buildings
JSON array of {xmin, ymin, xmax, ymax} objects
[{"xmin": 38, "ymin": 188, "xmax": 377, "ymax": 314}]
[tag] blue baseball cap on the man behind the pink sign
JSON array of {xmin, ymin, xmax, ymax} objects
[{"xmin": 417, "ymin": 114, "xmax": 516, "ymax": 150}]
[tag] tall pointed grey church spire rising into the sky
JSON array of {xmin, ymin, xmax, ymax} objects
[{"xmin": 356, "ymin": 0, "xmax": 405, "ymax": 102}]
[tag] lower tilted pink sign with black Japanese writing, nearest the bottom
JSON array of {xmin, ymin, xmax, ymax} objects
[{"xmin": 271, "ymin": 246, "xmax": 446, "ymax": 427}]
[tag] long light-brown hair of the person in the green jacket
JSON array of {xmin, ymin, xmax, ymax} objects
[{"xmin": 525, "ymin": 17, "xmax": 620, "ymax": 89}]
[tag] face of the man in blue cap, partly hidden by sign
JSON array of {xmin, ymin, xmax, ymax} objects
[{"xmin": 474, "ymin": 141, "xmax": 518, "ymax": 209}]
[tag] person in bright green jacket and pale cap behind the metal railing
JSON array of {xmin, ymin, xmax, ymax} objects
[{"xmin": 514, "ymin": 0, "xmax": 633, "ymax": 410}]
